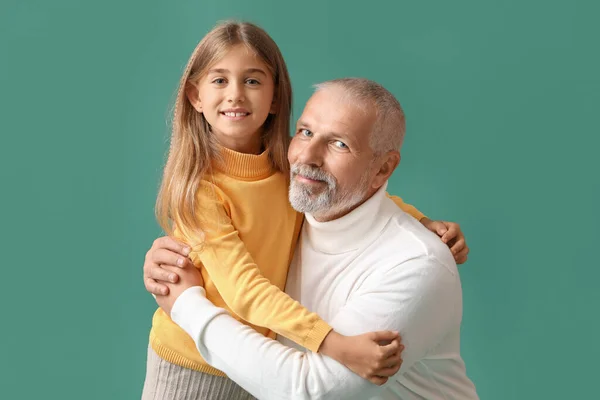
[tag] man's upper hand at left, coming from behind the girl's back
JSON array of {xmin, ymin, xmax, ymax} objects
[{"xmin": 144, "ymin": 236, "xmax": 194, "ymax": 296}]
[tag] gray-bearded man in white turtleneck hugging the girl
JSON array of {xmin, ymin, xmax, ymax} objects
[{"xmin": 144, "ymin": 78, "xmax": 478, "ymax": 400}]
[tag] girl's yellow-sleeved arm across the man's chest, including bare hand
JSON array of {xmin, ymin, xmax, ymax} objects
[{"xmin": 179, "ymin": 182, "xmax": 397, "ymax": 378}]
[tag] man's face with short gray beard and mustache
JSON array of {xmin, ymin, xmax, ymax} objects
[{"xmin": 288, "ymin": 88, "xmax": 376, "ymax": 221}]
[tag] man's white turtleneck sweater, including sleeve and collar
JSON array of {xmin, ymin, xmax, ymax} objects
[{"xmin": 171, "ymin": 185, "xmax": 478, "ymax": 400}]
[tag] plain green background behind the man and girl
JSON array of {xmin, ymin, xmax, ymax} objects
[{"xmin": 0, "ymin": 0, "xmax": 600, "ymax": 400}]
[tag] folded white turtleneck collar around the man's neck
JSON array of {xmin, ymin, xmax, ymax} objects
[{"xmin": 303, "ymin": 182, "xmax": 391, "ymax": 254}]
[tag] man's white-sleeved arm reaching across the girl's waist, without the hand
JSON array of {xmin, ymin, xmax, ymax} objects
[{"xmin": 171, "ymin": 258, "xmax": 461, "ymax": 399}]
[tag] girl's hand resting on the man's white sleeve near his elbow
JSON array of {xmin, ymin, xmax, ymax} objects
[{"xmin": 319, "ymin": 331, "xmax": 404, "ymax": 385}]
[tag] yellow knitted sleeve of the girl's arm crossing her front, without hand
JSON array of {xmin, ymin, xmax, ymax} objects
[{"xmin": 178, "ymin": 182, "xmax": 331, "ymax": 352}]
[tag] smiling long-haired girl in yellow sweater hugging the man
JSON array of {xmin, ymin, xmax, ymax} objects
[{"xmin": 142, "ymin": 22, "xmax": 464, "ymax": 399}]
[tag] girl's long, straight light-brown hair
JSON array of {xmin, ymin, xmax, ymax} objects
[{"xmin": 155, "ymin": 21, "xmax": 292, "ymax": 239}]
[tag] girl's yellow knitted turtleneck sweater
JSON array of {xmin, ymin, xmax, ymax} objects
[{"xmin": 150, "ymin": 148, "xmax": 423, "ymax": 376}]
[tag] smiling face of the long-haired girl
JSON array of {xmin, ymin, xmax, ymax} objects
[{"xmin": 186, "ymin": 44, "xmax": 275, "ymax": 154}]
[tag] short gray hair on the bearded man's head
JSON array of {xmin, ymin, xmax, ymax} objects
[{"xmin": 314, "ymin": 78, "xmax": 406, "ymax": 155}]
